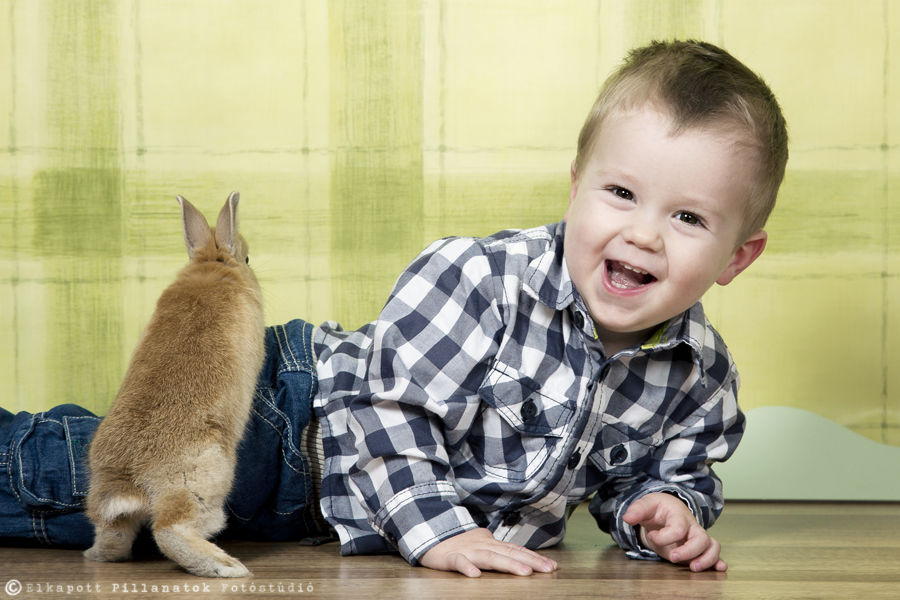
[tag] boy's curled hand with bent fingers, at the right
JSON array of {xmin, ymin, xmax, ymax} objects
[{"xmin": 622, "ymin": 493, "xmax": 728, "ymax": 572}]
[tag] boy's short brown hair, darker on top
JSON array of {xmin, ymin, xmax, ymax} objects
[{"xmin": 575, "ymin": 40, "xmax": 788, "ymax": 243}]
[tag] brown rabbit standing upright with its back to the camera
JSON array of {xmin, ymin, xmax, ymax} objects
[{"xmin": 85, "ymin": 192, "xmax": 265, "ymax": 577}]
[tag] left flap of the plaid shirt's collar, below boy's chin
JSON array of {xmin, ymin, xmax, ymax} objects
[{"xmin": 522, "ymin": 221, "xmax": 575, "ymax": 310}]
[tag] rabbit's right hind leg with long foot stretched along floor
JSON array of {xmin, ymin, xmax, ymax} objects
[{"xmin": 152, "ymin": 488, "xmax": 250, "ymax": 577}]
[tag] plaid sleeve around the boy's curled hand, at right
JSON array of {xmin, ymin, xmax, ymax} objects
[{"xmin": 590, "ymin": 364, "xmax": 745, "ymax": 560}]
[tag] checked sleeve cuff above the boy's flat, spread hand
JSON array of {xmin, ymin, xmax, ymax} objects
[{"xmin": 372, "ymin": 481, "xmax": 478, "ymax": 565}]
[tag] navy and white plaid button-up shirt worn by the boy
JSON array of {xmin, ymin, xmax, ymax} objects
[{"xmin": 315, "ymin": 223, "xmax": 744, "ymax": 564}]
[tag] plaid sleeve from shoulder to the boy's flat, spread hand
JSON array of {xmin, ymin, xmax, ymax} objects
[{"xmin": 348, "ymin": 238, "xmax": 502, "ymax": 564}]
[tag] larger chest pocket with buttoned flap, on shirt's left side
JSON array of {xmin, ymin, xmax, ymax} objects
[{"xmin": 468, "ymin": 364, "xmax": 574, "ymax": 482}]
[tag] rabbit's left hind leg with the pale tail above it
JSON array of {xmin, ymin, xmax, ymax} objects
[{"xmin": 84, "ymin": 488, "xmax": 147, "ymax": 562}]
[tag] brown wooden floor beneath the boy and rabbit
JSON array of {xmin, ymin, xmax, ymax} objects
[{"xmin": 0, "ymin": 503, "xmax": 900, "ymax": 600}]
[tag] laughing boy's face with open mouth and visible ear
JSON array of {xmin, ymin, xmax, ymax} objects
[{"xmin": 565, "ymin": 107, "xmax": 766, "ymax": 353}]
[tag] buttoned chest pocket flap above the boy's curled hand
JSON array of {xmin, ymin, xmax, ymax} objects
[{"xmin": 588, "ymin": 421, "xmax": 658, "ymax": 477}]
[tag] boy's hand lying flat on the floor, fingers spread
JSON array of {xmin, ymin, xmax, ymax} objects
[{"xmin": 419, "ymin": 527, "xmax": 557, "ymax": 577}]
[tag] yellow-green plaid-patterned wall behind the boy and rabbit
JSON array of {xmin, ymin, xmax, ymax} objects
[{"xmin": 0, "ymin": 0, "xmax": 900, "ymax": 497}]
